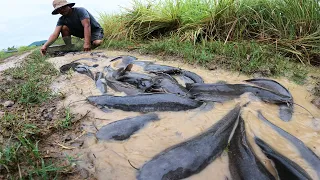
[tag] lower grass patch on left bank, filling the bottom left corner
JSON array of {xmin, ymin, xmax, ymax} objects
[{"xmin": 0, "ymin": 112, "xmax": 69, "ymax": 179}]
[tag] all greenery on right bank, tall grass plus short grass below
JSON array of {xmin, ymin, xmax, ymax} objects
[{"xmin": 100, "ymin": 0, "xmax": 320, "ymax": 81}]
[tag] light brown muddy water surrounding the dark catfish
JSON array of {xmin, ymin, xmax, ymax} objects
[{"xmin": 49, "ymin": 51, "xmax": 320, "ymax": 180}]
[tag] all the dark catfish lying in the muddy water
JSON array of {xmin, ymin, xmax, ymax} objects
[{"xmin": 60, "ymin": 56, "xmax": 320, "ymax": 180}]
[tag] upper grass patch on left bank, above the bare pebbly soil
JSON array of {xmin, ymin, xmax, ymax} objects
[{"xmin": 2, "ymin": 51, "xmax": 58, "ymax": 104}]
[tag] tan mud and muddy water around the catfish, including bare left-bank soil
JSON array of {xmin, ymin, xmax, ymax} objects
[{"xmin": 0, "ymin": 51, "xmax": 320, "ymax": 180}]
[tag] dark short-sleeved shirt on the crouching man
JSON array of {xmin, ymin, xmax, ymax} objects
[{"xmin": 57, "ymin": 7, "xmax": 102, "ymax": 38}]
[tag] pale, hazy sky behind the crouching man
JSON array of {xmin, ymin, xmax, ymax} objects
[{"xmin": 0, "ymin": 0, "xmax": 132, "ymax": 49}]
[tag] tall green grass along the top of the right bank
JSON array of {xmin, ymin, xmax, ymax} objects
[{"xmin": 101, "ymin": 0, "xmax": 320, "ymax": 64}]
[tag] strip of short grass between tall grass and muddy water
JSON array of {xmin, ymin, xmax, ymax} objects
[{"xmin": 105, "ymin": 38, "xmax": 308, "ymax": 84}]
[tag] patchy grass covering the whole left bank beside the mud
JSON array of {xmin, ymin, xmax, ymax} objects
[{"xmin": 0, "ymin": 51, "xmax": 73, "ymax": 179}]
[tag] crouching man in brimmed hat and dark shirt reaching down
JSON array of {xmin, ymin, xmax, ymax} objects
[{"xmin": 40, "ymin": 0, "xmax": 103, "ymax": 55}]
